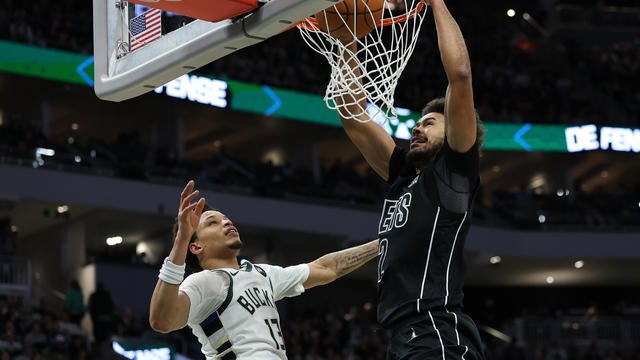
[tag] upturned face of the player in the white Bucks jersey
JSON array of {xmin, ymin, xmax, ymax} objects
[{"xmin": 196, "ymin": 210, "xmax": 242, "ymax": 251}]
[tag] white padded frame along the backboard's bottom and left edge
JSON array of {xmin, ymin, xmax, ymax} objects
[{"xmin": 93, "ymin": 0, "xmax": 340, "ymax": 101}]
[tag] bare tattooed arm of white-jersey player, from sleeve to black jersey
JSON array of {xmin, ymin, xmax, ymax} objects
[{"xmin": 304, "ymin": 239, "xmax": 378, "ymax": 289}]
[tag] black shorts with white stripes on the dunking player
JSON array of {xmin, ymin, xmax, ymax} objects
[{"xmin": 386, "ymin": 308, "xmax": 485, "ymax": 360}]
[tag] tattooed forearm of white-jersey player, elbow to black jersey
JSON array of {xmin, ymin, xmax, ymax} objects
[{"xmin": 315, "ymin": 239, "xmax": 378, "ymax": 278}]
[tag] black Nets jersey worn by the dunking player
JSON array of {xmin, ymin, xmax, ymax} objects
[{"xmin": 378, "ymin": 139, "xmax": 480, "ymax": 327}]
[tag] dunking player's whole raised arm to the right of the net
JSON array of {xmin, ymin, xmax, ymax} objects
[{"xmin": 429, "ymin": 0, "xmax": 477, "ymax": 152}]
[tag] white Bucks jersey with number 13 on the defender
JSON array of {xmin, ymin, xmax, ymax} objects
[{"xmin": 180, "ymin": 261, "xmax": 309, "ymax": 360}]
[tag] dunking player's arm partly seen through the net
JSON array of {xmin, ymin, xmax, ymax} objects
[{"xmin": 335, "ymin": 42, "xmax": 395, "ymax": 181}]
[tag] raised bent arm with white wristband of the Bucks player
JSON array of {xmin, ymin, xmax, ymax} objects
[{"xmin": 149, "ymin": 180, "xmax": 205, "ymax": 333}]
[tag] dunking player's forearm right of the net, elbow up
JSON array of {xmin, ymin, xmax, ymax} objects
[{"xmin": 430, "ymin": 0, "xmax": 471, "ymax": 82}]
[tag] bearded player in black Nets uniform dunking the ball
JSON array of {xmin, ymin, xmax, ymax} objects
[{"xmin": 338, "ymin": 0, "xmax": 484, "ymax": 360}]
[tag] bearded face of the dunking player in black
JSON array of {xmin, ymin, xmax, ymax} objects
[{"xmin": 407, "ymin": 112, "xmax": 444, "ymax": 165}]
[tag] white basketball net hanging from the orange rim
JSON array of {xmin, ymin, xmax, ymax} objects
[{"xmin": 298, "ymin": 0, "xmax": 426, "ymax": 122}]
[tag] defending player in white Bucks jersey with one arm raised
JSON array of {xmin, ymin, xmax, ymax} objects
[{"xmin": 149, "ymin": 181, "xmax": 378, "ymax": 360}]
